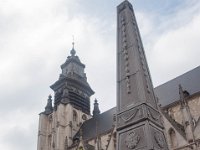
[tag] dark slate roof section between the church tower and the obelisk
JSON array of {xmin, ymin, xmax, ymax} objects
[{"xmin": 75, "ymin": 108, "xmax": 116, "ymax": 140}]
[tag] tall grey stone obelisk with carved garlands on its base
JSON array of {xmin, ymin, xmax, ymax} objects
[{"xmin": 117, "ymin": 0, "xmax": 168, "ymax": 150}]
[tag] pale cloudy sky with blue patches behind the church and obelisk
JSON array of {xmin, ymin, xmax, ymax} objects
[{"xmin": 0, "ymin": 0, "xmax": 200, "ymax": 150}]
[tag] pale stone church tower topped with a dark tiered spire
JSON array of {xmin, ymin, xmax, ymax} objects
[{"xmin": 37, "ymin": 44, "xmax": 94, "ymax": 150}]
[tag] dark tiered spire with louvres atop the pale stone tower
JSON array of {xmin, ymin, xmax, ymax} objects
[{"xmin": 50, "ymin": 40, "xmax": 94, "ymax": 114}]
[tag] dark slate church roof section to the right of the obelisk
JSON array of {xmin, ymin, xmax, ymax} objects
[{"xmin": 154, "ymin": 66, "xmax": 200, "ymax": 107}]
